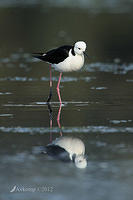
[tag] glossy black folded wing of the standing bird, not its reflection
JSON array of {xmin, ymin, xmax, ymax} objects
[{"xmin": 33, "ymin": 45, "xmax": 73, "ymax": 64}]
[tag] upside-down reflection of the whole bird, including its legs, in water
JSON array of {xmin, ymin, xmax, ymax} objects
[{"xmin": 43, "ymin": 104, "xmax": 87, "ymax": 168}]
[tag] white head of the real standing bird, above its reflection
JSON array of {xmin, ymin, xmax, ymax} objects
[{"xmin": 74, "ymin": 41, "xmax": 86, "ymax": 55}]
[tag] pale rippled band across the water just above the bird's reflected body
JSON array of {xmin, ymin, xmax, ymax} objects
[{"xmin": 0, "ymin": 126, "xmax": 133, "ymax": 134}]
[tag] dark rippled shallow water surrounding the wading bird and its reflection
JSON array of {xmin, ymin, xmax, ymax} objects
[{"xmin": 0, "ymin": 1, "xmax": 133, "ymax": 200}]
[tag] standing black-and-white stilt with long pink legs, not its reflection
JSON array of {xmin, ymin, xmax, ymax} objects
[{"xmin": 33, "ymin": 41, "xmax": 86, "ymax": 104}]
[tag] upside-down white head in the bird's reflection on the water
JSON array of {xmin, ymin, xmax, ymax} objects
[{"xmin": 74, "ymin": 155, "xmax": 87, "ymax": 169}]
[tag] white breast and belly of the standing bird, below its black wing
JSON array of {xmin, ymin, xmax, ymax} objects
[{"xmin": 53, "ymin": 55, "xmax": 84, "ymax": 72}]
